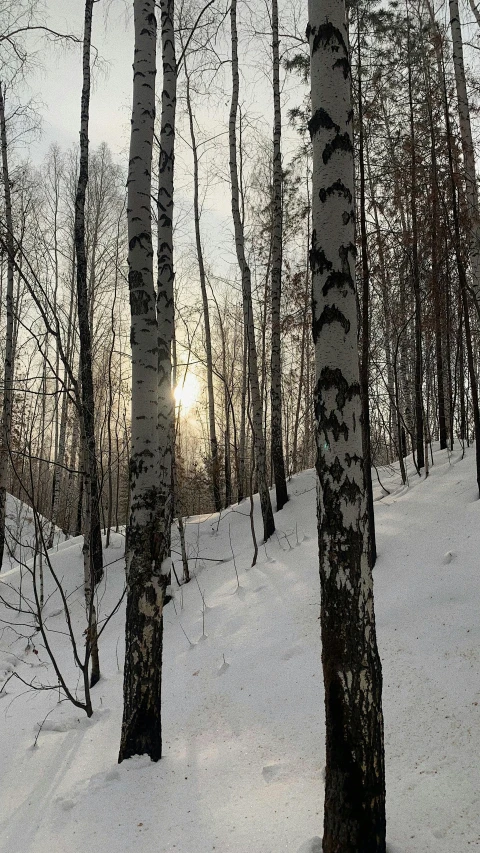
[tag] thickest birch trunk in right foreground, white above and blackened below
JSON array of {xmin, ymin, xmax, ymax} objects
[{"xmin": 307, "ymin": 0, "xmax": 385, "ymax": 853}]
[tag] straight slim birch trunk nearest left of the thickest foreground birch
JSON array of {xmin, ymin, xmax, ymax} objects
[{"xmin": 270, "ymin": 0, "xmax": 288, "ymax": 512}]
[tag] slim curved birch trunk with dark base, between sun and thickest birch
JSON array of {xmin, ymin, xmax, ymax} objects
[{"xmin": 228, "ymin": 0, "xmax": 275, "ymax": 541}]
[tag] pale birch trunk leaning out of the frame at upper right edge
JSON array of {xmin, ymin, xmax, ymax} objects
[{"xmin": 449, "ymin": 0, "xmax": 480, "ymax": 310}]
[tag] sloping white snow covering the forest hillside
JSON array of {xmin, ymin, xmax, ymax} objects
[{"xmin": 0, "ymin": 450, "xmax": 480, "ymax": 853}]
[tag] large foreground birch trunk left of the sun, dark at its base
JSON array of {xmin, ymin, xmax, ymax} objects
[{"xmin": 118, "ymin": 0, "xmax": 167, "ymax": 762}]
